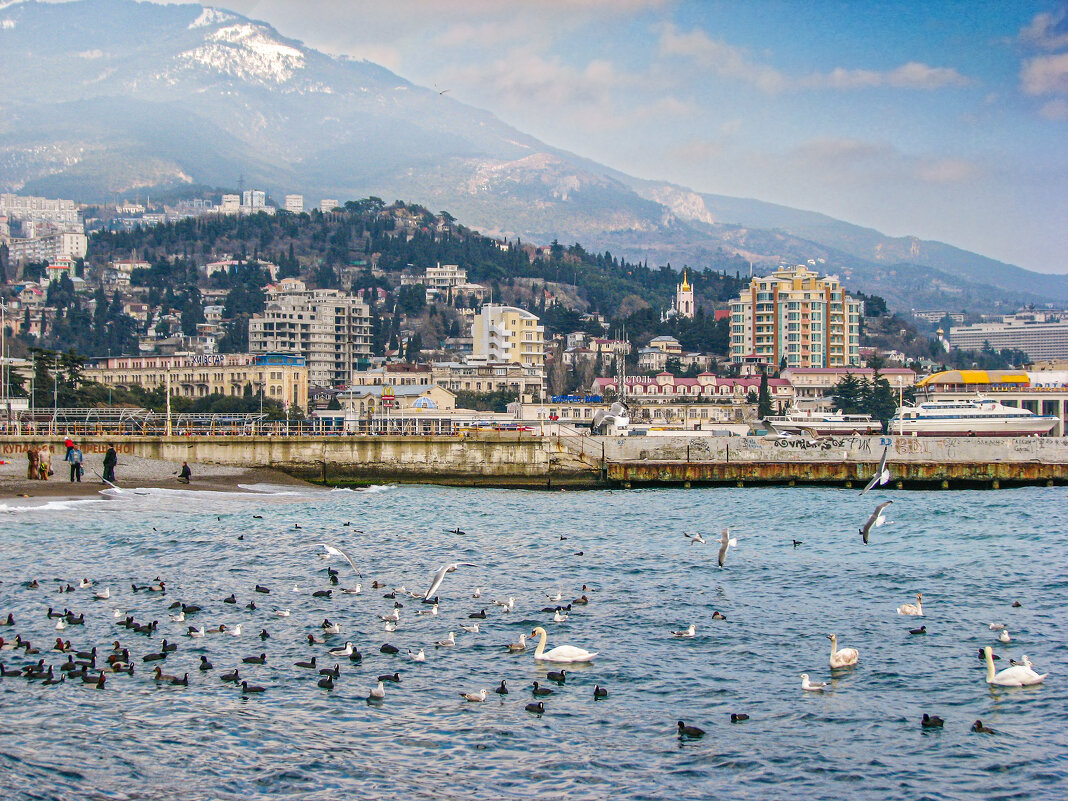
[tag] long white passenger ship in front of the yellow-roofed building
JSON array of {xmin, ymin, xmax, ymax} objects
[{"xmin": 888, "ymin": 396, "xmax": 1057, "ymax": 437}]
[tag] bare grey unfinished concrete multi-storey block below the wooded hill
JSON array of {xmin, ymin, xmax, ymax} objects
[{"xmin": 249, "ymin": 289, "xmax": 371, "ymax": 387}]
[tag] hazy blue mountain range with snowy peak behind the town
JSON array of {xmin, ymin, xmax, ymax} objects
[{"xmin": 0, "ymin": 0, "xmax": 1068, "ymax": 311}]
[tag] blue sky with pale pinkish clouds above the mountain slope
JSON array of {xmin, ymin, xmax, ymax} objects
[{"xmin": 166, "ymin": 0, "xmax": 1068, "ymax": 273}]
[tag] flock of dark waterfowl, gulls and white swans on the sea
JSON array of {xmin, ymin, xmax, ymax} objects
[{"xmin": 0, "ymin": 449, "xmax": 1048, "ymax": 740}]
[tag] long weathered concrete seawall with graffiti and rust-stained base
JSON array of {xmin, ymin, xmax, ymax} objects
[{"xmin": 0, "ymin": 431, "xmax": 1068, "ymax": 489}]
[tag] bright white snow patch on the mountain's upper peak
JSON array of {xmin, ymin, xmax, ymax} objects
[{"xmin": 177, "ymin": 21, "xmax": 304, "ymax": 83}]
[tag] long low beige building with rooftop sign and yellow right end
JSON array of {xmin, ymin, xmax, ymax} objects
[{"xmin": 82, "ymin": 354, "xmax": 308, "ymax": 409}]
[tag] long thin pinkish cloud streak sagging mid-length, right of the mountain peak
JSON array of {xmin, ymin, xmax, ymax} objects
[{"xmin": 657, "ymin": 22, "xmax": 972, "ymax": 94}]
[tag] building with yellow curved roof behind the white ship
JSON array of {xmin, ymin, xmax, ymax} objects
[{"xmin": 916, "ymin": 370, "xmax": 1068, "ymax": 437}]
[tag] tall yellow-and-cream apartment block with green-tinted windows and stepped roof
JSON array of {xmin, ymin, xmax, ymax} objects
[{"xmin": 731, "ymin": 265, "xmax": 862, "ymax": 367}]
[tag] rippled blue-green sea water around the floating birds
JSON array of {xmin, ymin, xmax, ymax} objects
[{"xmin": 0, "ymin": 485, "xmax": 1068, "ymax": 801}]
